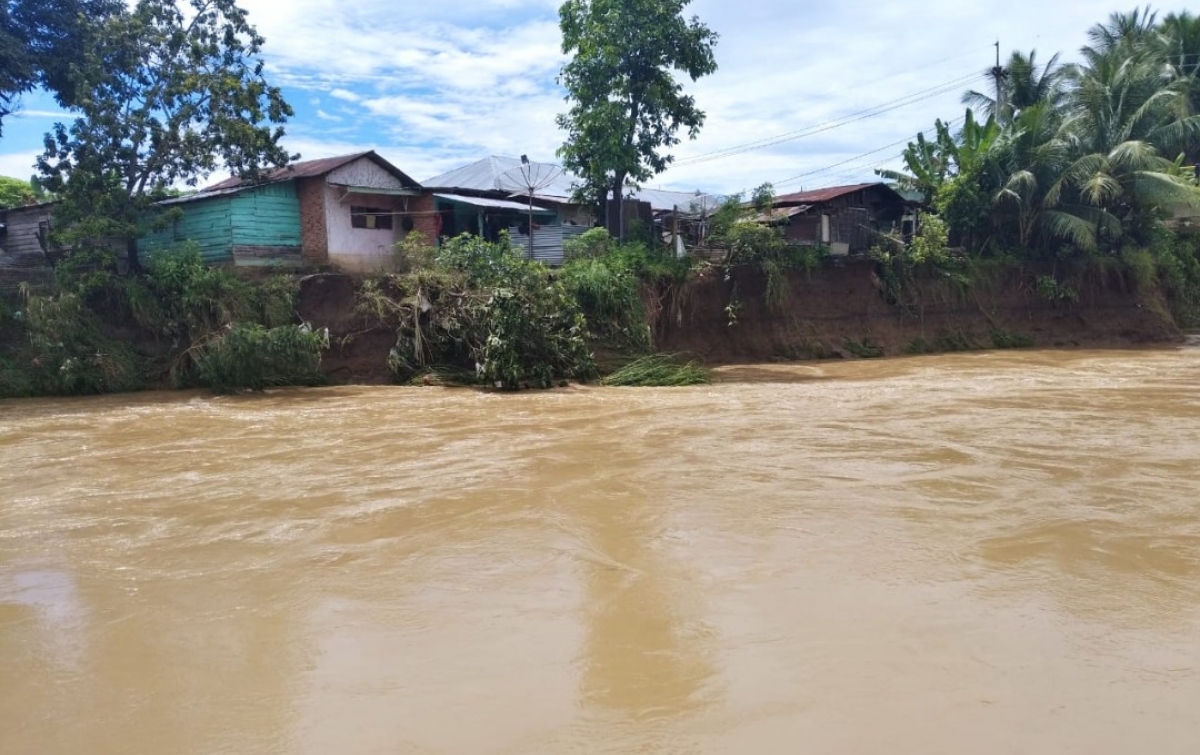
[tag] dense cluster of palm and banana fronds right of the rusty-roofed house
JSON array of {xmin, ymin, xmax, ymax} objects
[{"xmin": 881, "ymin": 8, "xmax": 1200, "ymax": 256}]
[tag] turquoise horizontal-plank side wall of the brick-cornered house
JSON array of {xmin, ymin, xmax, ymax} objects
[{"xmin": 138, "ymin": 181, "xmax": 300, "ymax": 264}]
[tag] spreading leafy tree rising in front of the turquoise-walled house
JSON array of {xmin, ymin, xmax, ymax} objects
[{"xmin": 38, "ymin": 0, "xmax": 292, "ymax": 270}]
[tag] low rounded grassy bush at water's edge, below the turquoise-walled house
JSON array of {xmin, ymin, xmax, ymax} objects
[{"xmin": 196, "ymin": 323, "xmax": 329, "ymax": 394}]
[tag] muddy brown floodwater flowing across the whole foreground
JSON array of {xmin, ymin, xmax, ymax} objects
[{"xmin": 0, "ymin": 344, "xmax": 1200, "ymax": 755}]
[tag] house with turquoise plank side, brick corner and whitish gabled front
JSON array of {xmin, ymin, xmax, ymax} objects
[{"xmin": 140, "ymin": 151, "xmax": 436, "ymax": 272}]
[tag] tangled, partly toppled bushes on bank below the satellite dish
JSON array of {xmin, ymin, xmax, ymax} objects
[{"xmin": 358, "ymin": 229, "xmax": 705, "ymax": 390}]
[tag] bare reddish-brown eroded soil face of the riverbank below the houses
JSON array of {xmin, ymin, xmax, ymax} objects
[{"xmin": 298, "ymin": 259, "xmax": 1182, "ymax": 384}]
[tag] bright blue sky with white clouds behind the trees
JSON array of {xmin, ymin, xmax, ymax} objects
[{"xmin": 0, "ymin": 0, "xmax": 1182, "ymax": 193}]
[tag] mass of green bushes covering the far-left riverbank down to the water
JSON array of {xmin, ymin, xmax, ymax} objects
[{"xmin": 0, "ymin": 241, "xmax": 325, "ymax": 395}]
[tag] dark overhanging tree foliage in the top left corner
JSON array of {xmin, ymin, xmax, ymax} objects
[{"xmin": 0, "ymin": 0, "xmax": 124, "ymax": 133}]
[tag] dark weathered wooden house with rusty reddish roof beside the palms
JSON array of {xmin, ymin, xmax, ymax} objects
[{"xmin": 769, "ymin": 182, "xmax": 908, "ymax": 254}]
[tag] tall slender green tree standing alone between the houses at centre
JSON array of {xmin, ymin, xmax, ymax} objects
[{"xmin": 558, "ymin": 0, "xmax": 716, "ymax": 235}]
